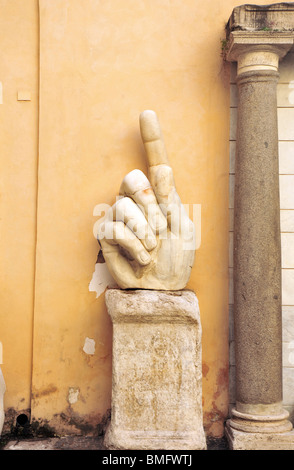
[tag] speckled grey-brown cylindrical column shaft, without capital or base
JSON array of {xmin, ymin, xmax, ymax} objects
[{"xmin": 234, "ymin": 70, "xmax": 282, "ymax": 414}]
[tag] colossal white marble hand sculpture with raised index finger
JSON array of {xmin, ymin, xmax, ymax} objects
[{"xmin": 97, "ymin": 110, "xmax": 195, "ymax": 290}]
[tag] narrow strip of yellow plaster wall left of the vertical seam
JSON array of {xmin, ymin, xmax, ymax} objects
[{"xmin": 0, "ymin": 0, "xmax": 38, "ymax": 420}]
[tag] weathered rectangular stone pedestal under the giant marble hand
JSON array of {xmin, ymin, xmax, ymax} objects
[{"xmin": 104, "ymin": 289, "xmax": 206, "ymax": 450}]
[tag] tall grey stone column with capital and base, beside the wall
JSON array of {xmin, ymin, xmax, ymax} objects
[{"xmin": 226, "ymin": 5, "xmax": 294, "ymax": 449}]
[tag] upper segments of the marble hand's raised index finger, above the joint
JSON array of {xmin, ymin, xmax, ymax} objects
[{"xmin": 140, "ymin": 110, "xmax": 169, "ymax": 167}]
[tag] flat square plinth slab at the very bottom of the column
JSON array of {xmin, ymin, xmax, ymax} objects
[{"xmin": 225, "ymin": 420, "xmax": 294, "ymax": 450}]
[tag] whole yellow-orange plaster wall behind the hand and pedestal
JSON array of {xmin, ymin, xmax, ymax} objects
[{"xmin": 0, "ymin": 0, "xmax": 274, "ymax": 436}]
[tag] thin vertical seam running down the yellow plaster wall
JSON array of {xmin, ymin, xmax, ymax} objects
[{"xmin": 30, "ymin": 0, "xmax": 40, "ymax": 412}]
